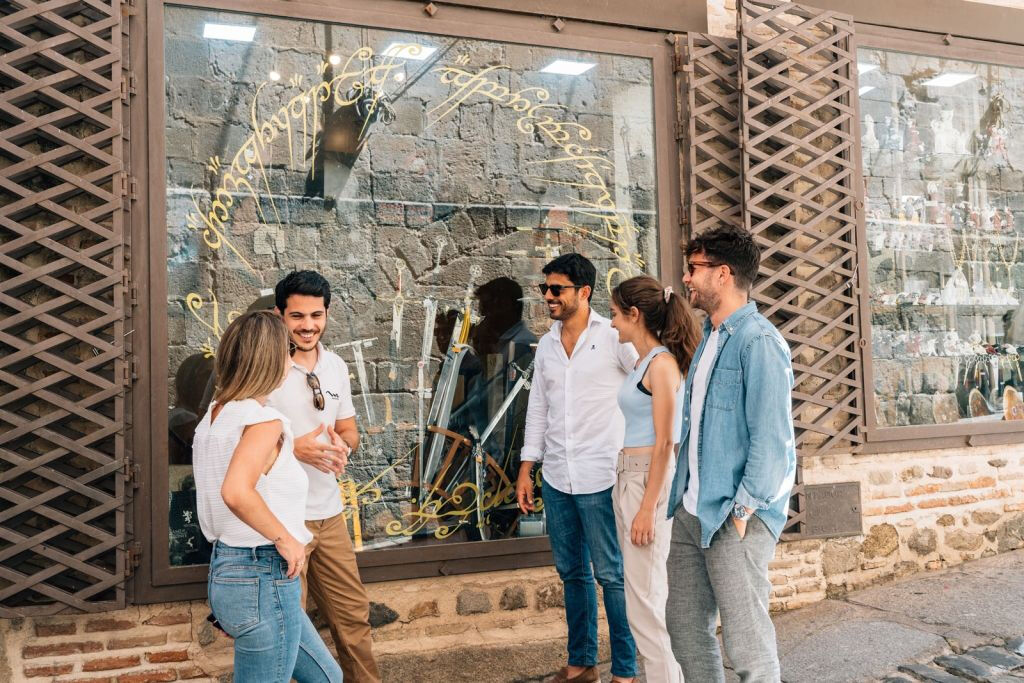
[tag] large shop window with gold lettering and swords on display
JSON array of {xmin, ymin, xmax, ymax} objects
[{"xmin": 164, "ymin": 7, "xmax": 658, "ymax": 566}]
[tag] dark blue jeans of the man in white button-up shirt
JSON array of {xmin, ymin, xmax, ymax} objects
[{"xmin": 543, "ymin": 482, "xmax": 637, "ymax": 678}]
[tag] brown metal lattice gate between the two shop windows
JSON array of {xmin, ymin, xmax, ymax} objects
[{"xmin": 677, "ymin": 0, "xmax": 864, "ymax": 538}]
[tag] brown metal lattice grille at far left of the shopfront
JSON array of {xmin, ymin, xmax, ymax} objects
[{"xmin": 0, "ymin": 0, "xmax": 131, "ymax": 617}]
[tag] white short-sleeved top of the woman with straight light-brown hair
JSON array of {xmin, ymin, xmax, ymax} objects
[{"xmin": 193, "ymin": 398, "xmax": 312, "ymax": 548}]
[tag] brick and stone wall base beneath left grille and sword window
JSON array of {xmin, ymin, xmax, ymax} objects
[{"xmin": 0, "ymin": 567, "xmax": 589, "ymax": 683}]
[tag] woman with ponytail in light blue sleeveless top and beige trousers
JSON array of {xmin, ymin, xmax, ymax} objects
[{"xmin": 611, "ymin": 275, "xmax": 700, "ymax": 683}]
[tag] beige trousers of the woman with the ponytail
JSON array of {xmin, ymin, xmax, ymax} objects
[{"xmin": 611, "ymin": 456, "xmax": 683, "ymax": 683}]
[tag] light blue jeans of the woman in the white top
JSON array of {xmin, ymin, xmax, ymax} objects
[{"xmin": 207, "ymin": 542, "xmax": 341, "ymax": 683}]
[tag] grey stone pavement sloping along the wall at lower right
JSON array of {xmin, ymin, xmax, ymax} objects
[{"xmin": 523, "ymin": 550, "xmax": 1024, "ymax": 683}]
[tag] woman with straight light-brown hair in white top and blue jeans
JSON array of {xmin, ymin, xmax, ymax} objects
[{"xmin": 193, "ymin": 311, "xmax": 342, "ymax": 683}]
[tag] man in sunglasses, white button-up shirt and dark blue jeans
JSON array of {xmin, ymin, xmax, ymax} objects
[{"xmin": 516, "ymin": 254, "xmax": 637, "ymax": 683}]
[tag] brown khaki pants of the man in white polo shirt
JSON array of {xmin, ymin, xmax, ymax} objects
[{"xmin": 302, "ymin": 514, "xmax": 381, "ymax": 683}]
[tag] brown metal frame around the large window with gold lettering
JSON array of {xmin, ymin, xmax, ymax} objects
[{"xmin": 132, "ymin": 0, "xmax": 682, "ymax": 603}]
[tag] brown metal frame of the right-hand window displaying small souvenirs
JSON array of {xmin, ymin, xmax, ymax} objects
[{"xmin": 857, "ymin": 22, "xmax": 1024, "ymax": 454}]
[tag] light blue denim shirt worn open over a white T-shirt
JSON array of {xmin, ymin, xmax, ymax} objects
[{"xmin": 669, "ymin": 302, "xmax": 797, "ymax": 548}]
